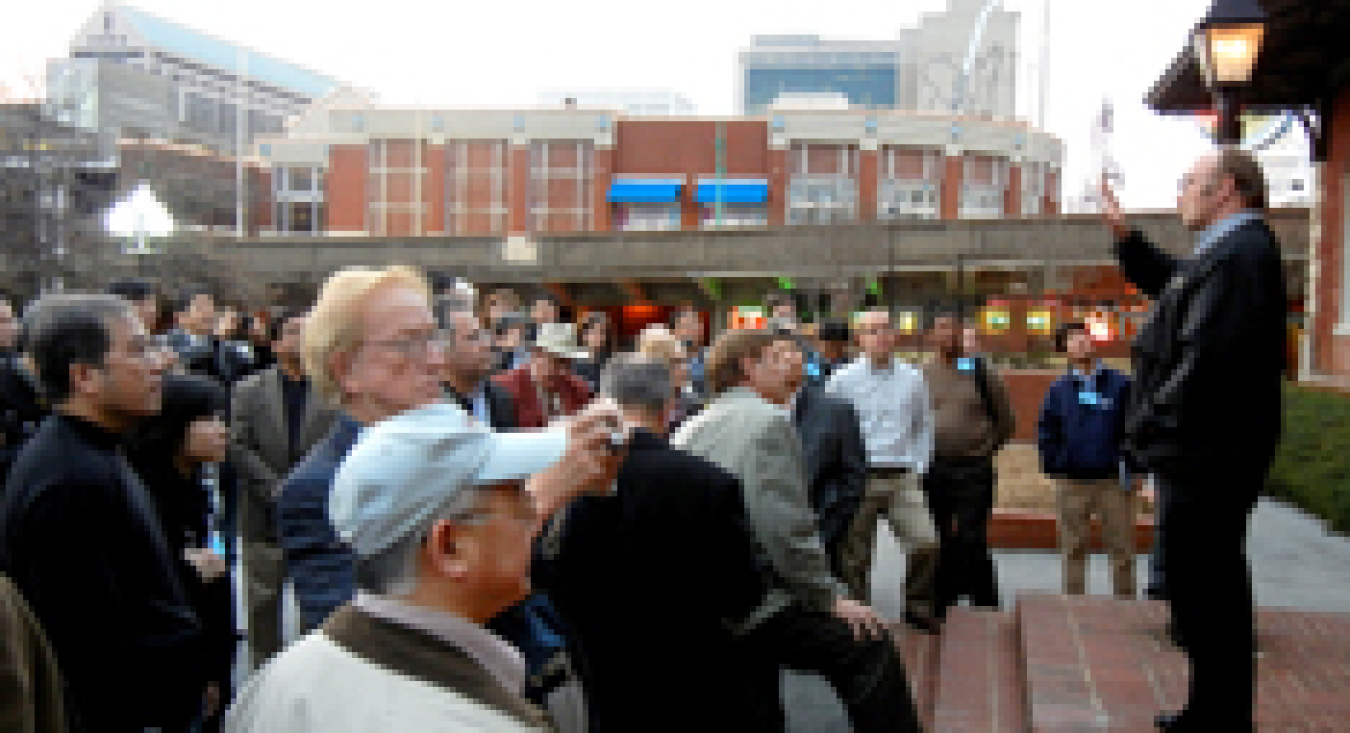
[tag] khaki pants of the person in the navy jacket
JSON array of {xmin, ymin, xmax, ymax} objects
[{"xmin": 1058, "ymin": 477, "xmax": 1134, "ymax": 598}]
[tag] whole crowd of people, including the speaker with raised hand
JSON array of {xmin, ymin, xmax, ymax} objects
[{"xmin": 0, "ymin": 146, "xmax": 1283, "ymax": 733}]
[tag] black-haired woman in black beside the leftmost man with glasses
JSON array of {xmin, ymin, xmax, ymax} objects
[{"xmin": 127, "ymin": 374, "xmax": 238, "ymax": 732}]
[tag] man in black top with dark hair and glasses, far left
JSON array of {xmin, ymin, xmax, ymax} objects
[{"xmin": 0, "ymin": 296, "xmax": 205, "ymax": 732}]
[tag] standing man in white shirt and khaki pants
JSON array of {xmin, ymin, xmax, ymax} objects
[{"xmin": 825, "ymin": 310, "xmax": 937, "ymax": 632}]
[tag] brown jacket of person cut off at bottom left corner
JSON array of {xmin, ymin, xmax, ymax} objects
[{"xmin": 0, "ymin": 575, "xmax": 66, "ymax": 733}]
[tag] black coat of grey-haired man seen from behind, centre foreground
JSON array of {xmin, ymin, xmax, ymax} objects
[{"xmin": 535, "ymin": 431, "xmax": 767, "ymax": 733}]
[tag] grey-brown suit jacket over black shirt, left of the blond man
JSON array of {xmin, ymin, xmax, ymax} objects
[{"xmin": 230, "ymin": 366, "xmax": 338, "ymax": 544}]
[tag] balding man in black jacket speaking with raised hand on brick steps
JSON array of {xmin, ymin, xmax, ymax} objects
[{"xmin": 1104, "ymin": 148, "xmax": 1288, "ymax": 730}]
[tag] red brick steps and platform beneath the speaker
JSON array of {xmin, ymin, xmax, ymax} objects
[{"xmin": 923, "ymin": 594, "xmax": 1350, "ymax": 733}]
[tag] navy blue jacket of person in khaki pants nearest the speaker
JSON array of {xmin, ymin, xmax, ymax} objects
[{"xmin": 1035, "ymin": 367, "xmax": 1130, "ymax": 479}]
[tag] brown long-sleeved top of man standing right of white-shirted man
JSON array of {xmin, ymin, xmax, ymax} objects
[{"xmin": 923, "ymin": 358, "xmax": 1017, "ymax": 459}]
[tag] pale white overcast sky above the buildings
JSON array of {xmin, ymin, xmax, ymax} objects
[{"xmin": 0, "ymin": 0, "xmax": 1231, "ymax": 208}]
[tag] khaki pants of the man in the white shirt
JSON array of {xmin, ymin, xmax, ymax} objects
[{"xmin": 840, "ymin": 472, "xmax": 937, "ymax": 618}]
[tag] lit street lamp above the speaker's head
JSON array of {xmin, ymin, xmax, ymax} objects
[{"xmin": 1191, "ymin": 0, "xmax": 1266, "ymax": 144}]
